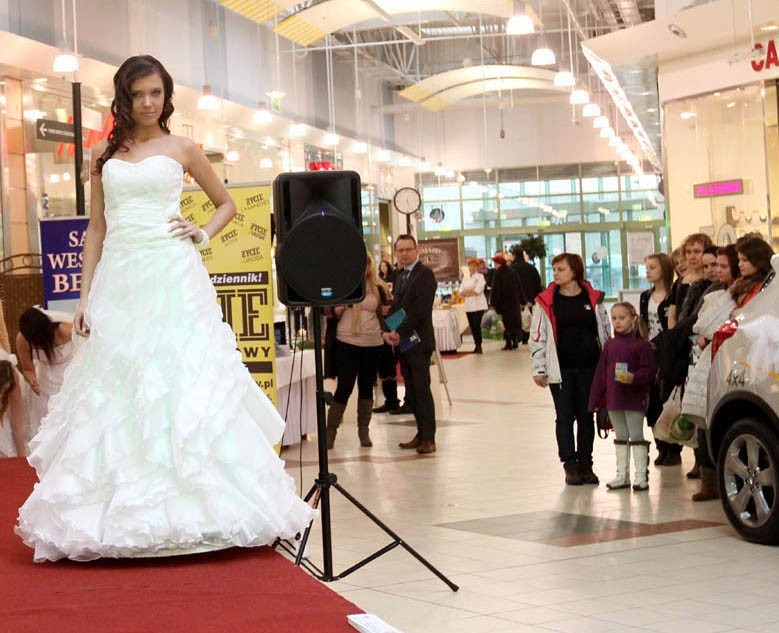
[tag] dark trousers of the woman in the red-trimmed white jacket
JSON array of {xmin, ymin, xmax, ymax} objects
[{"xmin": 549, "ymin": 367, "xmax": 595, "ymax": 464}]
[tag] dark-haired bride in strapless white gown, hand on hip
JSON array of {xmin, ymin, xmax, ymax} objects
[{"xmin": 16, "ymin": 56, "xmax": 315, "ymax": 561}]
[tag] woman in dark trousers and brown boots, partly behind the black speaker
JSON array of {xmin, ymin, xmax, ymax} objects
[{"xmin": 327, "ymin": 254, "xmax": 391, "ymax": 448}]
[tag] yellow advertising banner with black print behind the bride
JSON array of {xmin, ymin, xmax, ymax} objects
[{"xmin": 181, "ymin": 185, "xmax": 278, "ymax": 406}]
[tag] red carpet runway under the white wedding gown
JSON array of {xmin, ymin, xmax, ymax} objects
[{"xmin": 0, "ymin": 459, "xmax": 361, "ymax": 633}]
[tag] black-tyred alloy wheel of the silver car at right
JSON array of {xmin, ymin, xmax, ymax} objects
[{"xmin": 717, "ymin": 418, "xmax": 779, "ymax": 545}]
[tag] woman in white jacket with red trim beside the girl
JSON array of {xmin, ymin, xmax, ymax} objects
[{"xmin": 530, "ymin": 253, "xmax": 610, "ymax": 485}]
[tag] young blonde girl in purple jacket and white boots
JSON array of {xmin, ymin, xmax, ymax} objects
[{"xmin": 590, "ymin": 303, "xmax": 655, "ymax": 490}]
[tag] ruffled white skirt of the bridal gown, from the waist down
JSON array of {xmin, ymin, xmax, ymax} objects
[{"xmin": 16, "ymin": 242, "xmax": 315, "ymax": 561}]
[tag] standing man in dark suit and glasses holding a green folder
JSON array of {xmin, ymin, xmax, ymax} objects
[{"xmin": 383, "ymin": 235, "xmax": 437, "ymax": 454}]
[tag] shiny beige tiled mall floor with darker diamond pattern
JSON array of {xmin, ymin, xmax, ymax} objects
[{"xmin": 282, "ymin": 342, "xmax": 779, "ymax": 633}]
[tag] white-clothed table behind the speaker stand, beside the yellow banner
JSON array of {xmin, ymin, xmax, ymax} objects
[{"xmin": 276, "ymin": 349, "xmax": 316, "ymax": 446}]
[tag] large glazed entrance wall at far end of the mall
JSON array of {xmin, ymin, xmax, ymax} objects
[{"xmin": 420, "ymin": 162, "xmax": 665, "ymax": 298}]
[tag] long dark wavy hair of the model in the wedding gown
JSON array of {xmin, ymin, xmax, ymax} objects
[{"xmin": 95, "ymin": 55, "xmax": 173, "ymax": 174}]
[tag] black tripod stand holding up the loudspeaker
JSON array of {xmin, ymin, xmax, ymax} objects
[{"xmin": 284, "ymin": 308, "xmax": 459, "ymax": 591}]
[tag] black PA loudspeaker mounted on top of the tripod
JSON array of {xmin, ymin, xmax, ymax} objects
[{"xmin": 273, "ymin": 171, "xmax": 368, "ymax": 306}]
